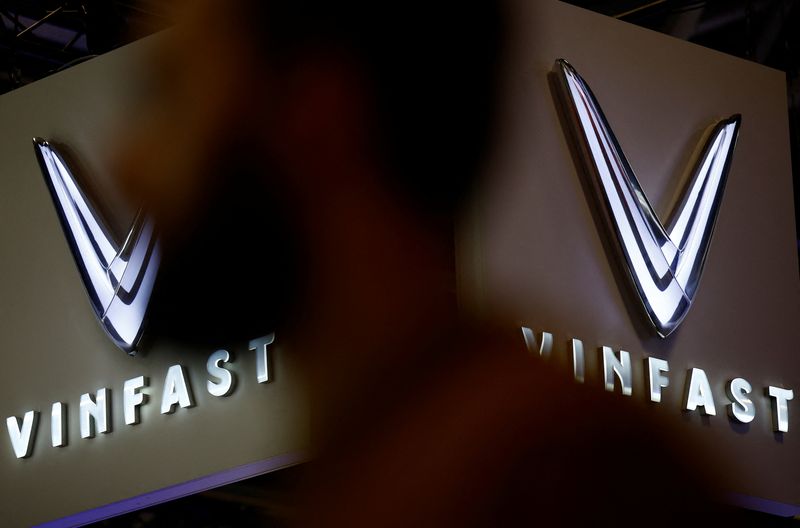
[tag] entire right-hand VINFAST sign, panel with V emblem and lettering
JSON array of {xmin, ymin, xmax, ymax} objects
[{"xmin": 459, "ymin": 1, "xmax": 800, "ymax": 513}]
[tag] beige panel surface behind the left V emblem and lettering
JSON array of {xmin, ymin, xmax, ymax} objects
[{"xmin": 0, "ymin": 37, "xmax": 306, "ymax": 526}]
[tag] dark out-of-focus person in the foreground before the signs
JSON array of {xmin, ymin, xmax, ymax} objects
[{"xmin": 111, "ymin": 0, "xmax": 736, "ymax": 526}]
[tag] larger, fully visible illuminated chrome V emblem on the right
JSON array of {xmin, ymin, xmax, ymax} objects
[{"xmin": 554, "ymin": 59, "xmax": 741, "ymax": 337}]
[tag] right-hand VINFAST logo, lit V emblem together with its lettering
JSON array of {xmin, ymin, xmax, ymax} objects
[{"xmin": 536, "ymin": 59, "xmax": 794, "ymax": 433}]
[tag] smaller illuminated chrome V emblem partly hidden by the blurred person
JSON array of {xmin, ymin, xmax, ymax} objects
[{"xmin": 33, "ymin": 138, "xmax": 160, "ymax": 355}]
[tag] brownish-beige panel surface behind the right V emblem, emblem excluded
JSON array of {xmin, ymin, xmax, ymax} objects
[{"xmin": 461, "ymin": 1, "xmax": 800, "ymax": 513}]
